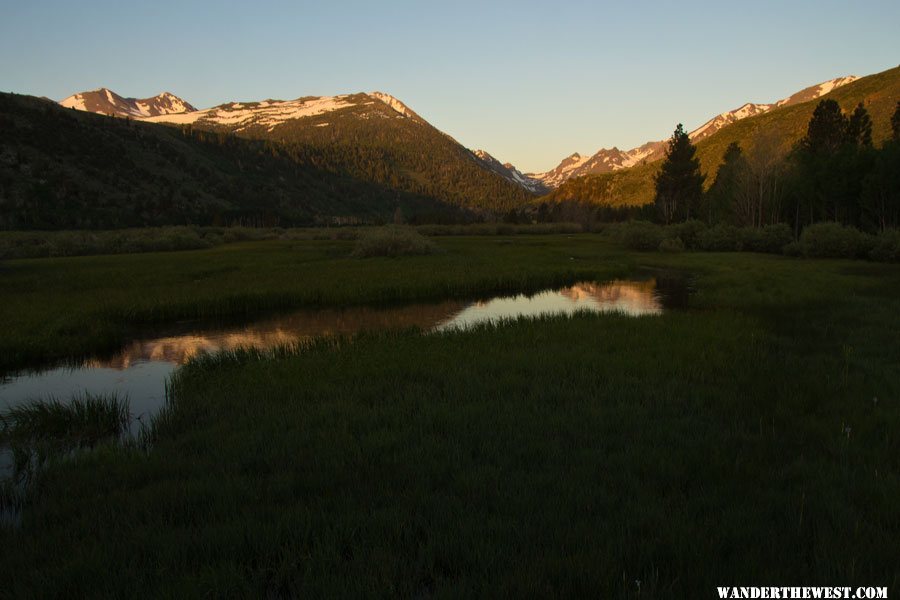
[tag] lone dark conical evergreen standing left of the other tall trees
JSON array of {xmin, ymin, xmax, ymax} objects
[{"xmin": 654, "ymin": 123, "xmax": 704, "ymax": 223}]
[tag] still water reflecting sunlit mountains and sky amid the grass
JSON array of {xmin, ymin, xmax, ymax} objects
[{"xmin": 0, "ymin": 278, "xmax": 668, "ymax": 424}]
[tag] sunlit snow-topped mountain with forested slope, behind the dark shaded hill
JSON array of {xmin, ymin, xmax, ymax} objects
[{"xmin": 143, "ymin": 92, "xmax": 544, "ymax": 212}]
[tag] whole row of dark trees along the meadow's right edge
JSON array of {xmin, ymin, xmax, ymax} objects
[{"xmin": 654, "ymin": 99, "xmax": 900, "ymax": 236}]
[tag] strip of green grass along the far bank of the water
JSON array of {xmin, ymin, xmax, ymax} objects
[{"xmin": 0, "ymin": 235, "xmax": 633, "ymax": 372}]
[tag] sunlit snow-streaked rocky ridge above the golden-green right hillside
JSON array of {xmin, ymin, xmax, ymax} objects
[{"xmin": 528, "ymin": 75, "xmax": 859, "ymax": 188}]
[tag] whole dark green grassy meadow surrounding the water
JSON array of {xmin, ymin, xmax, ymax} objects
[{"xmin": 0, "ymin": 234, "xmax": 900, "ymax": 598}]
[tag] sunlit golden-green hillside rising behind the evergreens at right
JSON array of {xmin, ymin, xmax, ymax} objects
[{"xmin": 542, "ymin": 67, "xmax": 900, "ymax": 206}]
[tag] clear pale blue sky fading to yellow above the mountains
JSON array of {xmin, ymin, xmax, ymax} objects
[{"xmin": 0, "ymin": 0, "xmax": 900, "ymax": 171}]
